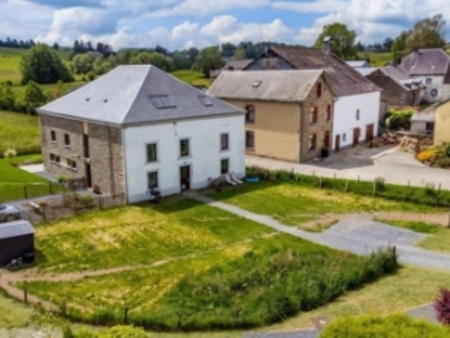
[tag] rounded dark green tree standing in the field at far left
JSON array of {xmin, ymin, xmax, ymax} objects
[{"xmin": 20, "ymin": 44, "xmax": 73, "ymax": 84}]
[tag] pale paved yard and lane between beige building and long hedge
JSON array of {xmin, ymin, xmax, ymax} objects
[{"xmin": 246, "ymin": 148, "xmax": 450, "ymax": 190}]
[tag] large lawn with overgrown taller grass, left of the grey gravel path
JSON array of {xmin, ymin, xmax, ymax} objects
[{"xmin": 16, "ymin": 199, "xmax": 395, "ymax": 331}]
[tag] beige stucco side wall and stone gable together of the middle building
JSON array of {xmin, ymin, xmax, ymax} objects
[{"xmin": 220, "ymin": 77, "xmax": 334, "ymax": 163}]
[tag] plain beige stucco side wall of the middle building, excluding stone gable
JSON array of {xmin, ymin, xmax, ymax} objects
[{"xmin": 225, "ymin": 100, "xmax": 301, "ymax": 162}]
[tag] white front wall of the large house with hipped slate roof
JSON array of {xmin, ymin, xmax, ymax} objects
[{"xmin": 123, "ymin": 115, "xmax": 245, "ymax": 203}]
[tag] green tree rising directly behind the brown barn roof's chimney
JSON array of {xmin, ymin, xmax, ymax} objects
[{"xmin": 314, "ymin": 22, "xmax": 357, "ymax": 60}]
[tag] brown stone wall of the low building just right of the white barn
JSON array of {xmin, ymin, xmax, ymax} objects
[{"xmin": 367, "ymin": 72, "xmax": 421, "ymax": 106}]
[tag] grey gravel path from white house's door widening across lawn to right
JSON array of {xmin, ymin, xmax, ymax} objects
[{"xmin": 190, "ymin": 194, "xmax": 450, "ymax": 271}]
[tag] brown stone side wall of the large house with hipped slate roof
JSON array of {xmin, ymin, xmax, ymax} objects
[{"xmin": 40, "ymin": 114, "xmax": 125, "ymax": 194}]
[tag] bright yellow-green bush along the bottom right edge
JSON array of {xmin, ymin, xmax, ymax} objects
[{"xmin": 320, "ymin": 315, "xmax": 450, "ymax": 338}]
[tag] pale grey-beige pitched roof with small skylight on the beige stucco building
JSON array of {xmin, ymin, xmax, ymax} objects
[{"xmin": 208, "ymin": 70, "xmax": 324, "ymax": 102}]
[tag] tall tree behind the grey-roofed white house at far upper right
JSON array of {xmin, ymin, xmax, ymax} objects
[{"xmin": 406, "ymin": 14, "xmax": 445, "ymax": 53}]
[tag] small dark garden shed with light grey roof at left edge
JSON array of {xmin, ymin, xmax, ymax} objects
[{"xmin": 0, "ymin": 220, "xmax": 34, "ymax": 266}]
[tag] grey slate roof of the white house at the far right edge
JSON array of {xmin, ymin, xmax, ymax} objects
[{"xmin": 401, "ymin": 48, "xmax": 450, "ymax": 76}]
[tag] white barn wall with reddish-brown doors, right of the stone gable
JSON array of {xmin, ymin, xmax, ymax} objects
[{"xmin": 333, "ymin": 92, "xmax": 381, "ymax": 151}]
